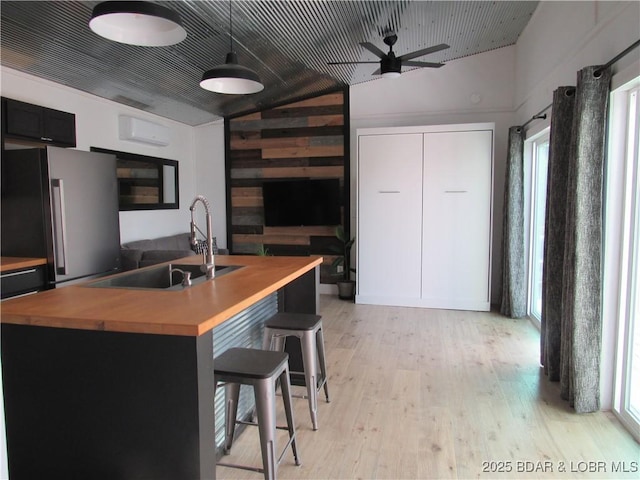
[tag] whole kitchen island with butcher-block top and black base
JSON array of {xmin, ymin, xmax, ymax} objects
[{"xmin": 1, "ymin": 255, "xmax": 322, "ymax": 479}]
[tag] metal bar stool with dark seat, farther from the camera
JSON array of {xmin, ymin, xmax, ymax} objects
[{"xmin": 263, "ymin": 312, "xmax": 329, "ymax": 430}]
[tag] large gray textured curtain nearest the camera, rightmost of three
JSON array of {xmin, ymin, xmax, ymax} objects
[{"xmin": 541, "ymin": 66, "xmax": 611, "ymax": 413}]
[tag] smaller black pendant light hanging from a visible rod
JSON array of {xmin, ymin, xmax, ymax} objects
[{"xmin": 200, "ymin": 0, "xmax": 264, "ymax": 95}]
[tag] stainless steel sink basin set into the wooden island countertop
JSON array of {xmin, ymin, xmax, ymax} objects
[{"xmin": 86, "ymin": 263, "xmax": 242, "ymax": 291}]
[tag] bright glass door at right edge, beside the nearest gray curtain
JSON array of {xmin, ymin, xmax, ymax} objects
[{"xmin": 603, "ymin": 78, "xmax": 640, "ymax": 442}]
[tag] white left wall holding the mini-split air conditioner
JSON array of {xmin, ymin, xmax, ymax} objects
[{"xmin": 0, "ymin": 67, "xmax": 225, "ymax": 243}]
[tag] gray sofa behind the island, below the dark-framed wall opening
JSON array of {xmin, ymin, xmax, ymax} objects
[{"xmin": 120, "ymin": 233, "xmax": 226, "ymax": 270}]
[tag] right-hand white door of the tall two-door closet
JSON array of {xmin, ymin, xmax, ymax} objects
[{"xmin": 422, "ymin": 130, "xmax": 493, "ymax": 310}]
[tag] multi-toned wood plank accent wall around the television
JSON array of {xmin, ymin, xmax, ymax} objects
[{"xmin": 225, "ymin": 88, "xmax": 349, "ymax": 283}]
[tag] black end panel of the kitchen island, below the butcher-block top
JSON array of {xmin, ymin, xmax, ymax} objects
[{"xmin": 1, "ymin": 324, "xmax": 215, "ymax": 480}]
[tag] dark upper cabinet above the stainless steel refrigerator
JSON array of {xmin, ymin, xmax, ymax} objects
[{"xmin": 2, "ymin": 98, "xmax": 76, "ymax": 147}]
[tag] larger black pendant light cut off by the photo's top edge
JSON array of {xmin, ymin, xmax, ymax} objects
[{"xmin": 89, "ymin": 1, "xmax": 187, "ymax": 47}]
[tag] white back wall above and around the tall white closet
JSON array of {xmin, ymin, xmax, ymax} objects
[{"xmin": 350, "ymin": 47, "xmax": 515, "ymax": 303}]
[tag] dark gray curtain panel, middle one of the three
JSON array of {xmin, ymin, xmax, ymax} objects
[{"xmin": 540, "ymin": 87, "xmax": 576, "ymax": 382}]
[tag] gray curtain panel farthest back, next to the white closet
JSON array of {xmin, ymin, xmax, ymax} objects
[{"xmin": 500, "ymin": 127, "xmax": 527, "ymax": 318}]
